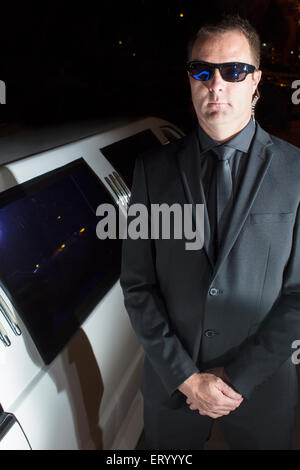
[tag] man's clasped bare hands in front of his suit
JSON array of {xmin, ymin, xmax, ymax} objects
[{"xmin": 178, "ymin": 373, "xmax": 243, "ymax": 418}]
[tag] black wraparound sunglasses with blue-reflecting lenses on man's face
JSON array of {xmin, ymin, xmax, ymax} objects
[{"xmin": 186, "ymin": 60, "xmax": 256, "ymax": 82}]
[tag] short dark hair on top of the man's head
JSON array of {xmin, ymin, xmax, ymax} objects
[{"xmin": 188, "ymin": 14, "xmax": 260, "ymax": 68}]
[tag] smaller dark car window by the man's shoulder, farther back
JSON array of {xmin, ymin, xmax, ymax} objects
[{"xmin": 100, "ymin": 130, "xmax": 161, "ymax": 188}]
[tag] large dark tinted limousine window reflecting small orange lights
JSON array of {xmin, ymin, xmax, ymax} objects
[{"xmin": 0, "ymin": 159, "xmax": 121, "ymax": 363}]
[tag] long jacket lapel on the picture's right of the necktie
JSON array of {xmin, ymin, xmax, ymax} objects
[{"xmin": 213, "ymin": 123, "xmax": 273, "ymax": 279}]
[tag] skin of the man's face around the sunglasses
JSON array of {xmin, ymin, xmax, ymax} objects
[{"xmin": 189, "ymin": 31, "xmax": 261, "ymax": 131}]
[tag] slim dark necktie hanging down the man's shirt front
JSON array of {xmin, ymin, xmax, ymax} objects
[{"xmin": 213, "ymin": 145, "xmax": 235, "ymax": 247}]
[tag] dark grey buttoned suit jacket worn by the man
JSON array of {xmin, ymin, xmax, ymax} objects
[{"xmin": 121, "ymin": 123, "xmax": 300, "ymax": 407}]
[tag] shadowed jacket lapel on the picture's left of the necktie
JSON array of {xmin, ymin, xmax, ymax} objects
[{"xmin": 177, "ymin": 131, "xmax": 214, "ymax": 268}]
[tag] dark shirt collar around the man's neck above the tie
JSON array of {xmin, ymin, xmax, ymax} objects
[{"xmin": 198, "ymin": 117, "xmax": 255, "ymax": 153}]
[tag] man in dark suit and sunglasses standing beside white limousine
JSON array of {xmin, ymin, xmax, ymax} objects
[{"xmin": 121, "ymin": 16, "xmax": 300, "ymax": 449}]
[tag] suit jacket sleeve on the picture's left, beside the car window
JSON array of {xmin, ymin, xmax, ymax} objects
[{"xmin": 120, "ymin": 156, "xmax": 199, "ymax": 396}]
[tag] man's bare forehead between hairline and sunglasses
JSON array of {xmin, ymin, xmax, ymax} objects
[{"xmin": 191, "ymin": 31, "xmax": 253, "ymax": 64}]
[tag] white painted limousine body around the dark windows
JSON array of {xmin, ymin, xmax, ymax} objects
[{"xmin": 0, "ymin": 118, "xmax": 182, "ymax": 450}]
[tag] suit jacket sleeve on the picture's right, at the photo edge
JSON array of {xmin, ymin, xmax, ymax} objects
[{"xmin": 225, "ymin": 200, "xmax": 300, "ymax": 398}]
